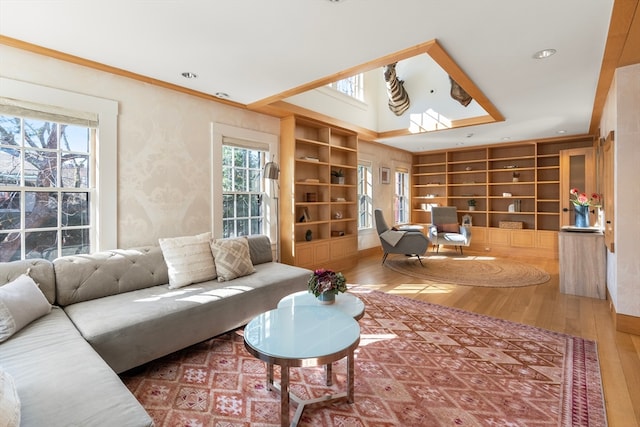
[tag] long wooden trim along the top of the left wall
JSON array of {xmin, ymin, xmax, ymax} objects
[{"xmin": 0, "ymin": 35, "xmax": 246, "ymax": 108}]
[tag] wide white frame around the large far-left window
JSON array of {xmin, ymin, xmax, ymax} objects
[{"xmin": 0, "ymin": 77, "xmax": 118, "ymax": 252}]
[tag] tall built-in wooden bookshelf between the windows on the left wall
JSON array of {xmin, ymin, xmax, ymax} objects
[{"xmin": 280, "ymin": 116, "xmax": 358, "ymax": 269}]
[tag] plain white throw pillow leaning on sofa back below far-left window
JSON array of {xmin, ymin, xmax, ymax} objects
[{"xmin": 0, "ymin": 274, "xmax": 51, "ymax": 342}]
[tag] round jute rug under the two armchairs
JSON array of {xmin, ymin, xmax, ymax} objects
[{"xmin": 384, "ymin": 255, "xmax": 549, "ymax": 288}]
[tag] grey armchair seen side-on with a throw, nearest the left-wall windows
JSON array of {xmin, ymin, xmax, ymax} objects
[{"xmin": 374, "ymin": 209, "xmax": 429, "ymax": 267}]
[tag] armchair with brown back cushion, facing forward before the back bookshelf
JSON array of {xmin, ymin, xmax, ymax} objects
[{"xmin": 428, "ymin": 206, "xmax": 471, "ymax": 254}]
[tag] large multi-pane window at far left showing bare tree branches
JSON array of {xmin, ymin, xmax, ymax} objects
[{"xmin": 0, "ymin": 114, "xmax": 96, "ymax": 262}]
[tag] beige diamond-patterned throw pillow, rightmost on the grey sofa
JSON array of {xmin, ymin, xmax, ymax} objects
[{"xmin": 211, "ymin": 237, "xmax": 256, "ymax": 282}]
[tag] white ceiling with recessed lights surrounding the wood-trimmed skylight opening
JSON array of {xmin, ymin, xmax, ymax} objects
[{"xmin": 0, "ymin": 0, "xmax": 613, "ymax": 151}]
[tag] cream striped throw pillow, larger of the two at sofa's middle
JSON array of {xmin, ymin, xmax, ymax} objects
[{"xmin": 159, "ymin": 232, "xmax": 217, "ymax": 289}]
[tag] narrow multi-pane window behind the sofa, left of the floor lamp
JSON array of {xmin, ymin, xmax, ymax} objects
[{"xmin": 222, "ymin": 145, "xmax": 266, "ymax": 237}]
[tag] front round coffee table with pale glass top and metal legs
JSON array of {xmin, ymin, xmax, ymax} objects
[{"xmin": 244, "ymin": 305, "xmax": 360, "ymax": 426}]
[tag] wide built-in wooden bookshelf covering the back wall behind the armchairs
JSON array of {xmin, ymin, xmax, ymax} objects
[{"xmin": 411, "ymin": 136, "xmax": 593, "ymax": 256}]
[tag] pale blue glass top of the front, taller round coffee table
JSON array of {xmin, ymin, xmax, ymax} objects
[{"xmin": 244, "ymin": 305, "xmax": 360, "ymax": 360}]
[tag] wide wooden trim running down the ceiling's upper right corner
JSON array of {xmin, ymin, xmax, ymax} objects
[{"xmin": 589, "ymin": 0, "xmax": 640, "ymax": 135}]
